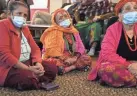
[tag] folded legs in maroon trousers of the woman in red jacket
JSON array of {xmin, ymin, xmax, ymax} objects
[{"xmin": 4, "ymin": 61, "xmax": 57, "ymax": 90}]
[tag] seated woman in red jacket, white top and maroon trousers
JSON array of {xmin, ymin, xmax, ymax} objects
[{"xmin": 0, "ymin": 1, "xmax": 57, "ymax": 90}]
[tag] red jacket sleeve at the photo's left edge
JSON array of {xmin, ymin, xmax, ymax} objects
[{"xmin": 0, "ymin": 22, "xmax": 18, "ymax": 66}]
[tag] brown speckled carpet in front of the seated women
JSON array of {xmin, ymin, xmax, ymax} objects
[{"xmin": 0, "ymin": 57, "xmax": 137, "ymax": 96}]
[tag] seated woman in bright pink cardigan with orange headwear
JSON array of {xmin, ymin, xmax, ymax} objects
[{"xmin": 88, "ymin": 0, "xmax": 137, "ymax": 87}]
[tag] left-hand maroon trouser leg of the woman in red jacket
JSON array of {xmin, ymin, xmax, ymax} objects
[{"xmin": 4, "ymin": 68, "xmax": 38, "ymax": 90}]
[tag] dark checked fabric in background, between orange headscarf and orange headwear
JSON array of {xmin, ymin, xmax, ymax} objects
[{"xmin": 78, "ymin": 0, "xmax": 114, "ymax": 17}]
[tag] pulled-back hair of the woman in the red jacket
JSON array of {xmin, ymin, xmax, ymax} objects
[{"xmin": 8, "ymin": 1, "xmax": 28, "ymax": 12}]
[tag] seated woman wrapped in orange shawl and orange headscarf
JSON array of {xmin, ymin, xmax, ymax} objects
[{"xmin": 40, "ymin": 9, "xmax": 91, "ymax": 75}]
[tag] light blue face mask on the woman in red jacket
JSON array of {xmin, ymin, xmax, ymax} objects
[{"xmin": 12, "ymin": 16, "xmax": 26, "ymax": 28}]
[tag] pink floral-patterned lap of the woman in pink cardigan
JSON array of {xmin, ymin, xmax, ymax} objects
[{"xmin": 98, "ymin": 62, "xmax": 136, "ymax": 87}]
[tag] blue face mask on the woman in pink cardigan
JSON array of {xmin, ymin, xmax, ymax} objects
[{"xmin": 122, "ymin": 11, "xmax": 137, "ymax": 25}]
